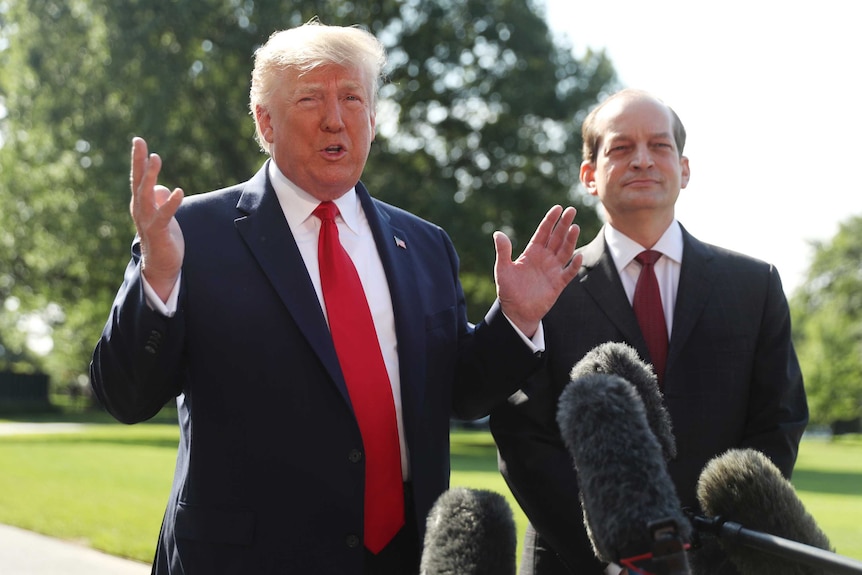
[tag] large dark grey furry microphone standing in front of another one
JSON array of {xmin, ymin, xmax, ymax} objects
[{"xmin": 557, "ymin": 372, "xmax": 691, "ymax": 575}]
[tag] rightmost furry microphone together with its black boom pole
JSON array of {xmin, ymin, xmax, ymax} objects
[{"xmin": 692, "ymin": 449, "xmax": 862, "ymax": 575}]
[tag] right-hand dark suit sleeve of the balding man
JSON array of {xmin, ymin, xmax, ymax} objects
[{"xmin": 741, "ymin": 268, "xmax": 808, "ymax": 478}]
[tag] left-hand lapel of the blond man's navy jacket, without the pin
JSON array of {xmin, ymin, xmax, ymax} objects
[{"xmin": 234, "ymin": 164, "xmax": 349, "ymax": 403}]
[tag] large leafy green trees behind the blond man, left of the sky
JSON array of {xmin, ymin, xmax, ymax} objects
[{"xmin": 0, "ymin": 0, "xmax": 615, "ymax": 390}]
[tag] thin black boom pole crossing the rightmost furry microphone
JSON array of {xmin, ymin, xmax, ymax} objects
[{"xmin": 691, "ymin": 515, "xmax": 862, "ymax": 575}]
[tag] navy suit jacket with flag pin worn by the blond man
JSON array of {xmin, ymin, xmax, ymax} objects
[{"xmin": 91, "ymin": 166, "xmax": 540, "ymax": 575}]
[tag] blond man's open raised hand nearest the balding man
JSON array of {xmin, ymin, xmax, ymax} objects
[{"xmin": 494, "ymin": 206, "xmax": 582, "ymax": 337}]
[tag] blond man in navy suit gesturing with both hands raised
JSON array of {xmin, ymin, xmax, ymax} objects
[{"xmin": 91, "ymin": 22, "xmax": 578, "ymax": 575}]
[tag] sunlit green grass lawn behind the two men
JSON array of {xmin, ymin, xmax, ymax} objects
[{"xmin": 0, "ymin": 423, "xmax": 862, "ymax": 562}]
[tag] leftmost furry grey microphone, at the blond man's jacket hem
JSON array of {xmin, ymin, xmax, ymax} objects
[{"xmin": 419, "ymin": 487, "xmax": 517, "ymax": 575}]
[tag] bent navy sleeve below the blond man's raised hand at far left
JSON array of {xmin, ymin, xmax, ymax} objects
[{"xmin": 90, "ymin": 242, "xmax": 183, "ymax": 423}]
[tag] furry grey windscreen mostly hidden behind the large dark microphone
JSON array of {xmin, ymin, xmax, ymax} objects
[{"xmin": 569, "ymin": 341, "xmax": 676, "ymax": 461}]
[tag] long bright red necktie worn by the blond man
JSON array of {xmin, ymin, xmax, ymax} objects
[{"xmin": 314, "ymin": 202, "xmax": 404, "ymax": 553}]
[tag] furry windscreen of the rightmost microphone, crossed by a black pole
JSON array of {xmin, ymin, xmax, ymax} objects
[{"xmin": 697, "ymin": 449, "xmax": 831, "ymax": 575}]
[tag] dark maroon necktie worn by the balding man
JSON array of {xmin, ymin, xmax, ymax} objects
[{"xmin": 632, "ymin": 250, "xmax": 667, "ymax": 385}]
